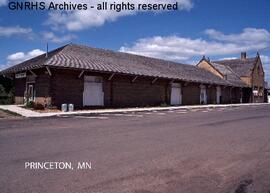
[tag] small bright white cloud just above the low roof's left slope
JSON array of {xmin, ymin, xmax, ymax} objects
[{"xmin": 7, "ymin": 49, "xmax": 45, "ymax": 65}]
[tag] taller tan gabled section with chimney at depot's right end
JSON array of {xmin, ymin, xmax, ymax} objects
[{"xmin": 197, "ymin": 53, "xmax": 265, "ymax": 103}]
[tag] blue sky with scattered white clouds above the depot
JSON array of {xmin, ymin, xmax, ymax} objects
[{"xmin": 0, "ymin": 0, "xmax": 270, "ymax": 82}]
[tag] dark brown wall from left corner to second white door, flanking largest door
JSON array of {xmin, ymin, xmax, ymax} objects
[{"xmin": 50, "ymin": 70, "xmax": 168, "ymax": 108}]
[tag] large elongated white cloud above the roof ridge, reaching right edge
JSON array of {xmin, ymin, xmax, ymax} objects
[{"xmin": 120, "ymin": 28, "xmax": 270, "ymax": 61}]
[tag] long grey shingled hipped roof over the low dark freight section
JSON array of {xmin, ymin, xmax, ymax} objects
[{"xmin": 1, "ymin": 44, "xmax": 230, "ymax": 85}]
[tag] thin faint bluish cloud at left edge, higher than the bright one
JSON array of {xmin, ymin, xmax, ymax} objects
[{"xmin": 0, "ymin": 26, "xmax": 32, "ymax": 37}]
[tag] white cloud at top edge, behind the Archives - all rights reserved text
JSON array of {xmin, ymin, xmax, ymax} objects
[{"xmin": 46, "ymin": 0, "xmax": 193, "ymax": 31}]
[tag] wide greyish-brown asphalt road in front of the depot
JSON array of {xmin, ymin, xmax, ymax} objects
[{"xmin": 0, "ymin": 105, "xmax": 270, "ymax": 193}]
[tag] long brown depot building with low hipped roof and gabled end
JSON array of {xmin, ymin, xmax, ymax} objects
[{"xmin": 1, "ymin": 44, "xmax": 267, "ymax": 109}]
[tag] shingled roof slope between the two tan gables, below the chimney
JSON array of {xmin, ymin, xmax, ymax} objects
[{"xmin": 213, "ymin": 56, "xmax": 258, "ymax": 76}]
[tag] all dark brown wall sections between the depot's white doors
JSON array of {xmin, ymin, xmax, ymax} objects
[{"xmin": 12, "ymin": 69, "xmax": 246, "ymax": 109}]
